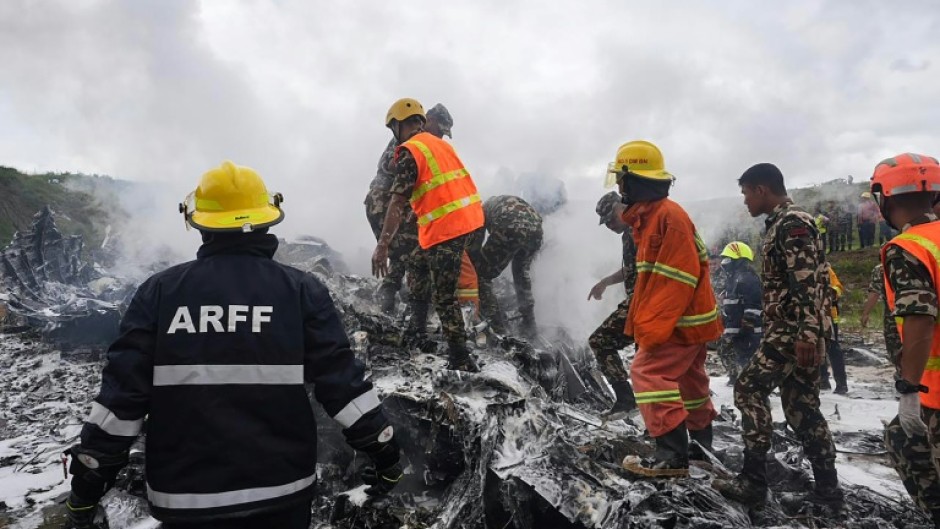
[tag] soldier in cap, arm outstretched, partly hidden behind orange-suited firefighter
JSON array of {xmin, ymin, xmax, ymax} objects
[{"xmin": 588, "ymin": 191, "xmax": 636, "ymax": 419}]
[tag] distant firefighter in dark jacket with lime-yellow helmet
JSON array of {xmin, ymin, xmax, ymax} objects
[{"xmin": 718, "ymin": 241, "xmax": 763, "ymax": 386}]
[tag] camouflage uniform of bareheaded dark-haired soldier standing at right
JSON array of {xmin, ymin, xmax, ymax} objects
[{"xmin": 734, "ymin": 201, "xmax": 836, "ymax": 470}]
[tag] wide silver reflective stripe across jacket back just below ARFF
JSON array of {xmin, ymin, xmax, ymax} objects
[{"xmin": 153, "ymin": 364, "xmax": 304, "ymax": 386}]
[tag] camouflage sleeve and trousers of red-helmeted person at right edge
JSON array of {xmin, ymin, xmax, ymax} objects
[{"xmin": 872, "ymin": 214, "xmax": 940, "ymax": 512}]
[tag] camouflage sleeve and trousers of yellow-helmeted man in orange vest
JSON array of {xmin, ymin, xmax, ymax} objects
[{"xmin": 389, "ymin": 149, "xmax": 482, "ymax": 344}]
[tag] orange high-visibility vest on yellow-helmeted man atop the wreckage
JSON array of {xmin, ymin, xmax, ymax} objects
[{"xmin": 396, "ymin": 132, "xmax": 483, "ymax": 250}]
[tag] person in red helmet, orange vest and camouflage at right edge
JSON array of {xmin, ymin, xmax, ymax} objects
[{"xmin": 865, "ymin": 153, "xmax": 940, "ymax": 528}]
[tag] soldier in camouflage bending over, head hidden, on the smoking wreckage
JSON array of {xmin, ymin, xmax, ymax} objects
[{"xmin": 468, "ymin": 195, "xmax": 542, "ymax": 339}]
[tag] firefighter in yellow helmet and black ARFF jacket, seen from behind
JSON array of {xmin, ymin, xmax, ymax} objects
[{"xmin": 67, "ymin": 162, "xmax": 402, "ymax": 529}]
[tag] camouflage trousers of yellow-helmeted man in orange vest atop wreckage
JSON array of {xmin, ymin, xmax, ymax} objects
[{"xmin": 408, "ymin": 234, "xmax": 478, "ymax": 343}]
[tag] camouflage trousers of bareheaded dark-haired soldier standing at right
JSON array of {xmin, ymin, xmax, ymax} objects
[{"xmin": 734, "ymin": 341, "xmax": 836, "ymax": 467}]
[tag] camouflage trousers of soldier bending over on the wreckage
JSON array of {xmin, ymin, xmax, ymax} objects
[{"xmin": 468, "ymin": 227, "xmax": 542, "ymax": 322}]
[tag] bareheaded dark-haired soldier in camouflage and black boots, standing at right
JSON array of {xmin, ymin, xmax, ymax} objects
[{"xmin": 713, "ymin": 163, "xmax": 843, "ymax": 509}]
